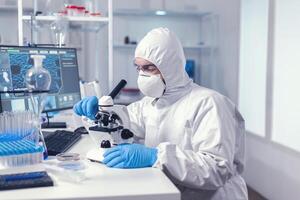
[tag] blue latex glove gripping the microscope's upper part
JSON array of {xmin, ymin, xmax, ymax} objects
[{"xmin": 73, "ymin": 96, "xmax": 98, "ymax": 119}]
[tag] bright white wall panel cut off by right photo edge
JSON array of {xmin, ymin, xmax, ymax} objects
[{"xmin": 272, "ymin": 0, "xmax": 300, "ymax": 152}]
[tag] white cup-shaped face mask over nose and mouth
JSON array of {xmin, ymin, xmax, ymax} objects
[{"xmin": 137, "ymin": 72, "xmax": 166, "ymax": 98}]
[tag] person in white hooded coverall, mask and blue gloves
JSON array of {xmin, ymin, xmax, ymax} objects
[{"xmin": 74, "ymin": 28, "xmax": 248, "ymax": 200}]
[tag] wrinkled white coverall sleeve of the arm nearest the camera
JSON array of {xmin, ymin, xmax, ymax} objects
[{"xmin": 154, "ymin": 96, "xmax": 236, "ymax": 190}]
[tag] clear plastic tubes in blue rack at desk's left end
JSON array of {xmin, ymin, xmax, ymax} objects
[{"xmin": 0, "ymin": 111, "xmax": 45, "ymax": 168}]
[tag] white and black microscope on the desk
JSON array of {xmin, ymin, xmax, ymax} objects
[{"xmin": 83, "ymin": 80, "xmax": 133, "ymax": 162}]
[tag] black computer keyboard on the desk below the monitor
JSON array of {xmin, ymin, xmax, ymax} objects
[{"xmin": 43, "ymin": 130, "xmax": 81, "ymax": 156}]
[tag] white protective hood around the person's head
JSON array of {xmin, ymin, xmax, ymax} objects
[{"xmin": 135, "ymin": 28, "xmax": 192, "ymax": 107}]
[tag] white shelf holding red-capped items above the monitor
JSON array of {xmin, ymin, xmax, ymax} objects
[{"xmin": 22, "ymin": 15, "xmax": 109, "ymax": 22}]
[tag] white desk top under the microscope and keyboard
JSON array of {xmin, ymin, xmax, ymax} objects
[{"xmin": 0, "ymin": 114, "xmax": 180, "ymax": 200}]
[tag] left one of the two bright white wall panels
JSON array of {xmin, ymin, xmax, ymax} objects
[{"xmin": 238, "ymin": 0, "xmax": 269, "ymax": 136}]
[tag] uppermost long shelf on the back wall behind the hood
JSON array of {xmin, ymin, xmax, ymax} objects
[{"xmin": 114, "ymin": 9, "xmax": 210, "ymax": 17}]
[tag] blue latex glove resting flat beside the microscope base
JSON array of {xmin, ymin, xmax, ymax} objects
[{"xmin": 103, "ymin": 144, "xmax": 157, "ymax": 168}]
